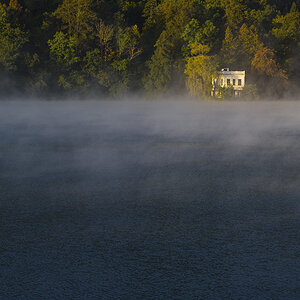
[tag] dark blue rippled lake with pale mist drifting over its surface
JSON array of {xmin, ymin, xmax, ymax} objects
[{"xmin": 0, "ymin": 101, "xmax": 300, "ymax": 299}]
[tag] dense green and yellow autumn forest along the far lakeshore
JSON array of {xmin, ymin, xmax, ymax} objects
[{"xmin": 0, "ymin": 0, "xmax": 300, "ymax": 99}]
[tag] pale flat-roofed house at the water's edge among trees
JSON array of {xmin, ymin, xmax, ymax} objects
[{"xmin": 211, "ymin": 68, "xmax": 246, "ymax": 97}]
